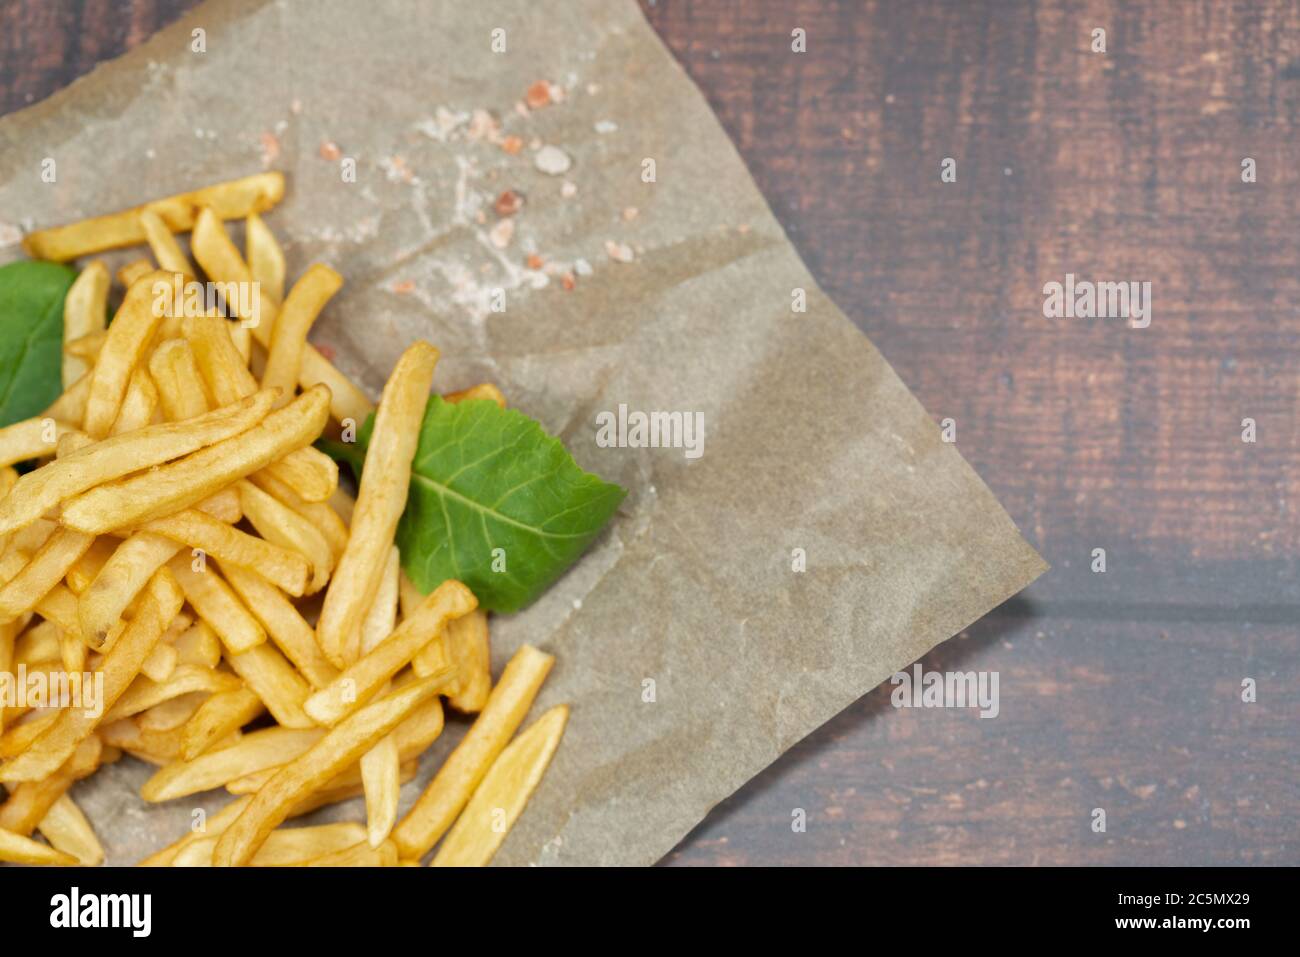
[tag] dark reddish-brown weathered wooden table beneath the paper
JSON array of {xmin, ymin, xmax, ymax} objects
[{"xmin": 0, "ymin": 0, "xmax": 1300, "ymax": 865}]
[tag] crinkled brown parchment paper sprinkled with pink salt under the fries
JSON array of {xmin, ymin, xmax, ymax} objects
[{"xmin": 0, "ymin": 0, "xmax": 1045, "ymax": 865}]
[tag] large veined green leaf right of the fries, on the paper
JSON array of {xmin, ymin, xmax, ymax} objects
[{"xmin": 400, "ymin": 395, "xmax": 627, "ymax": 611}]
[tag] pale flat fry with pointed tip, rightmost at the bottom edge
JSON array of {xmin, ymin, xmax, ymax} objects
[{"xmin": 432, "ymin": 705, "xmax": 568, "ymax": 867}]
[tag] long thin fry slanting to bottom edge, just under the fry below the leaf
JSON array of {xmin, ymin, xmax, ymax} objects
[{"xmin": 212, "ymin": 679, "xmax": 438, "ymax": 867}]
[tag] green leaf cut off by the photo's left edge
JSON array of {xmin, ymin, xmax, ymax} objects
[{"xmin": 0, "ymin": 260, "xmax": 77, "ymax": 426}]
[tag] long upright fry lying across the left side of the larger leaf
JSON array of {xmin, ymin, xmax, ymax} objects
[{"xmin": 316, "ymin": 342, "xmax": 438, "ymax": 666}]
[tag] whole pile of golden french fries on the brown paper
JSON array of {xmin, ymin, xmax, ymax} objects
[{"xmin": 0, "ymin": 173, "xmax": 568, "ymax": 866}]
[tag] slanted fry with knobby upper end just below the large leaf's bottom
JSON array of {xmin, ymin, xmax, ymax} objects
[{"xmin": 304, "ymin": 581, "xmax": 477, "ymax": 724}]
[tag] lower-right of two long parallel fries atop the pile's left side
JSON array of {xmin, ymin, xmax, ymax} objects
[{"xmin": 61, "ymin": 389, "xmax": 329, "ymax": 534}]
